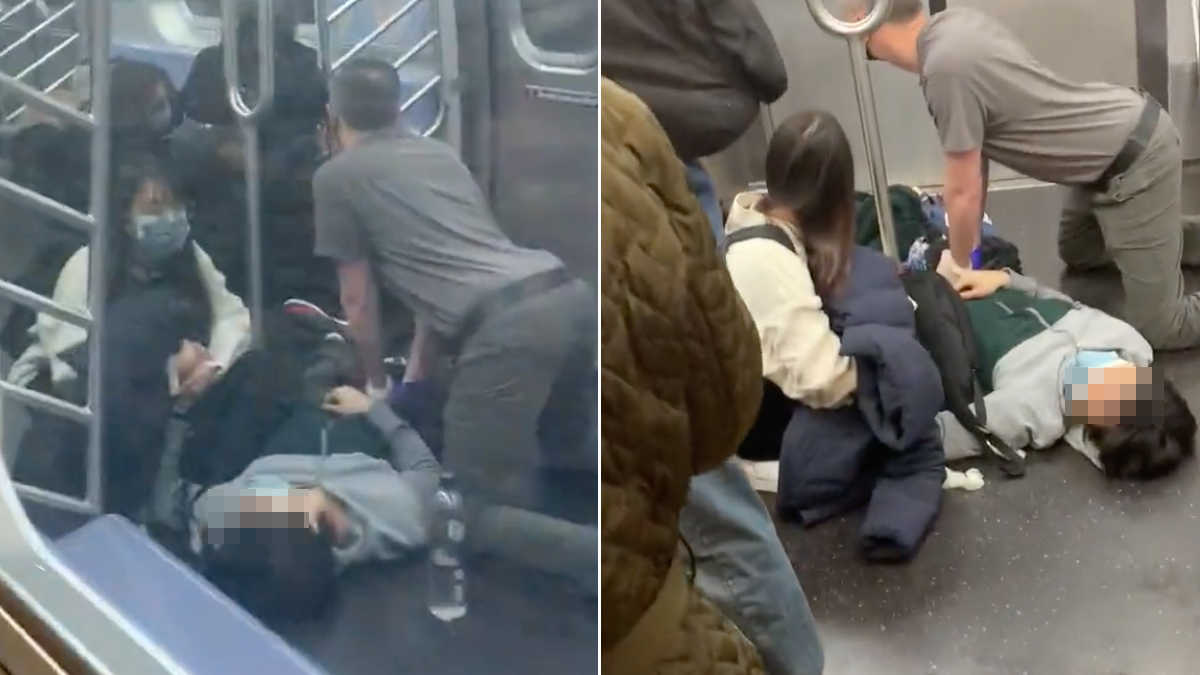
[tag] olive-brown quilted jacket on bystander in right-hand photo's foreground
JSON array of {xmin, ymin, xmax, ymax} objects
[{"xmin": 600, "ymin": 79, "xmax": 762, "ymax": 675}]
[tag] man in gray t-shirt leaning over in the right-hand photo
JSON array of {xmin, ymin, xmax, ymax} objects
[{"xmin": 858, "ymin": 0, "xmax": 1200, "ymax": 348}]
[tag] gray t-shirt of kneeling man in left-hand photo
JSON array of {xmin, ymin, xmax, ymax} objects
[{"xmin": 313, "ymin": 133, "xmax": 563, "ymax": 338}]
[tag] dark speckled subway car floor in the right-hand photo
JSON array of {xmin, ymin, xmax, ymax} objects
[{"xmin": 768, "ymin": 180, "xmax": 1200, "ymax": 675}]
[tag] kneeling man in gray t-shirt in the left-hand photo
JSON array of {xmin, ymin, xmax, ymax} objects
[{"xmin": 313, "ymin": 59, "xmax": 596, "ymax": 507}]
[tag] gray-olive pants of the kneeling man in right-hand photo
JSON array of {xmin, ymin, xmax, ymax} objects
[{"xmin": 1058, "ymin": 112, "xmax": 1200, "ymax": 350}]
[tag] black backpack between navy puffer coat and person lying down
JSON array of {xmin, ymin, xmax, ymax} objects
[{"xmin": 901, "ymin": 270, "xmax": 1025, "ymax": 478}]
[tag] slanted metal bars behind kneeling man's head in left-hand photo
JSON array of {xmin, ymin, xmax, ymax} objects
[{"xmin": 313, "ymin": 0, "xmax": 457, "ymax": 142}]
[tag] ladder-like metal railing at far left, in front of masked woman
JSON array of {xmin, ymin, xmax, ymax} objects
[{"xmin": 0, "ymin": 0, "xmax": 112, "ymax": 514}]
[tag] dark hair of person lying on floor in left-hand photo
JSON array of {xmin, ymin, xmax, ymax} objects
[{"xmin": 200, "ymin": 526, "xmax": 337, "ymax": 622}]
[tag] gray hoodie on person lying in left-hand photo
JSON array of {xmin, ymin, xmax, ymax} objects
[{"xmin": 193, "ymin": 402, "xmax": 440, "ymax": 568}]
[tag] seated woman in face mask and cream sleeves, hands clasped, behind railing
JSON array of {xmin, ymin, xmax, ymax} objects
[{"xmin": 8, "ymin": 154, "xmax": 251, "ymax": 509}]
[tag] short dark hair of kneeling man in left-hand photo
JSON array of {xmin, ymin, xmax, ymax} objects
[{"xmin": 330, "ymin": 59, "xmax": 401, "ymax": 131}]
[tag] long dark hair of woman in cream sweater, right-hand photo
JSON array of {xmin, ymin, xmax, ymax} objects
[{"xmin": 758, "ymin": 110, "xmax": 854, "ymax": 298}]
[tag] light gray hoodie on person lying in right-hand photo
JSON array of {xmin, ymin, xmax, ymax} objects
[{"xmin": 937, "ymin": 273, "xmax": 1154, "ymax": 467}]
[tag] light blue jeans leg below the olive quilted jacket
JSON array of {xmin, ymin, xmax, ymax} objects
[{"xmin": 679, "ymin": 460, "xmax": 824, "ymax": 675}]
